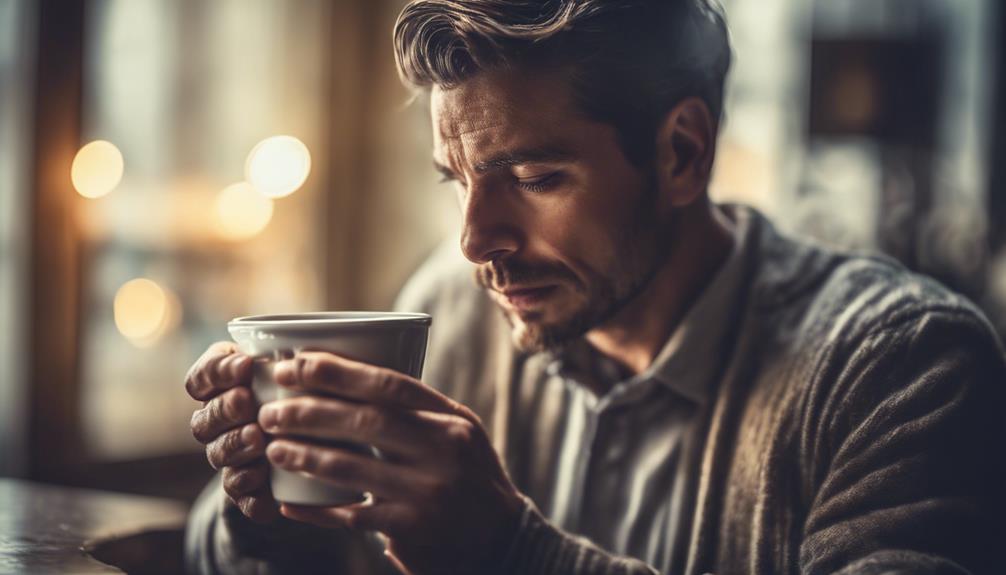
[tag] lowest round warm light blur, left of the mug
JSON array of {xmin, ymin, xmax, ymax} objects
[{"xmin": 113, "ymin": 277, "xmax": 180, "ymax": 348}]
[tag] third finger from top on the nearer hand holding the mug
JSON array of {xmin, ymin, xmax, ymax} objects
[{"xmin": 266, "ymin": 439, "xmax": 429, "ymax": 499}]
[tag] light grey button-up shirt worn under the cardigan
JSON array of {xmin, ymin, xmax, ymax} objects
[{"xmin": 512, "ymin": 208, "xmax": 747, "ymax": 572}]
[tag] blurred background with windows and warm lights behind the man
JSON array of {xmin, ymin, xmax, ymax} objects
[{"xmin": 0, "ymin": 0, "xmax": 1006, "ymax": 500}]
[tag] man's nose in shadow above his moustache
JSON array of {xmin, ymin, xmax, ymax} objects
[{"xmin": 461, "ymin": 186, "xmax": 522, "ymax": 263}]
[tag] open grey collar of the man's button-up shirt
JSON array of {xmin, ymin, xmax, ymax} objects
[{"xmin": 549, "ymin": 206, "xmax": 753, "ymax": 403}]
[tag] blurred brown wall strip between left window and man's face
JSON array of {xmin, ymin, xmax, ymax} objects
[{"xmin": 328, "ymin": 0, "xmax": 459, "ymax": 310}]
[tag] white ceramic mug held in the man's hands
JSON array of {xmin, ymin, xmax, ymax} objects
[{"xmin": 227, "ymin": 312, "xmax": 432, "ymax": 506}]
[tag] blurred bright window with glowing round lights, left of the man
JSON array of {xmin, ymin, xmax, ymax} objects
[{"xmin": 80, "ymin": 0, "xmax": 329, "ymax": 459}]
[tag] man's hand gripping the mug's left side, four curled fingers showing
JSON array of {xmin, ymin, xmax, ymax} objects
[{"xmin": 185, "ymin": 342, "xmax": 279, "ymax": 522}]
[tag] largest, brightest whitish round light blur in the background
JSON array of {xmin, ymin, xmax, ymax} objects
[{"xmin": 244, "ymin": 136, "xmax": 311, "ymax": 198}]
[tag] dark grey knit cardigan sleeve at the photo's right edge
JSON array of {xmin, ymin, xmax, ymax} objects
[{"xmin": 800, "ymin": 308, "xmax": 1006, "ymax": 575}]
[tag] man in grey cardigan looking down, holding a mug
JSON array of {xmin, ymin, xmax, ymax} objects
[{"xmin": 187, "ymin": 0, "xmax": 1006, "ymax": 575}]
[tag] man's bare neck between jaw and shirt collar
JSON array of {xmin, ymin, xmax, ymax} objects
[{"xmin": 586, "ymin": 202, "xmax": 734, "ymax": 375}]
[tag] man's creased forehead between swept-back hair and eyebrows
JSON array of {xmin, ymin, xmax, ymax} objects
[{"xmin": 430, "ymin": 72, "xmax": 586, "ymax": 165}]
